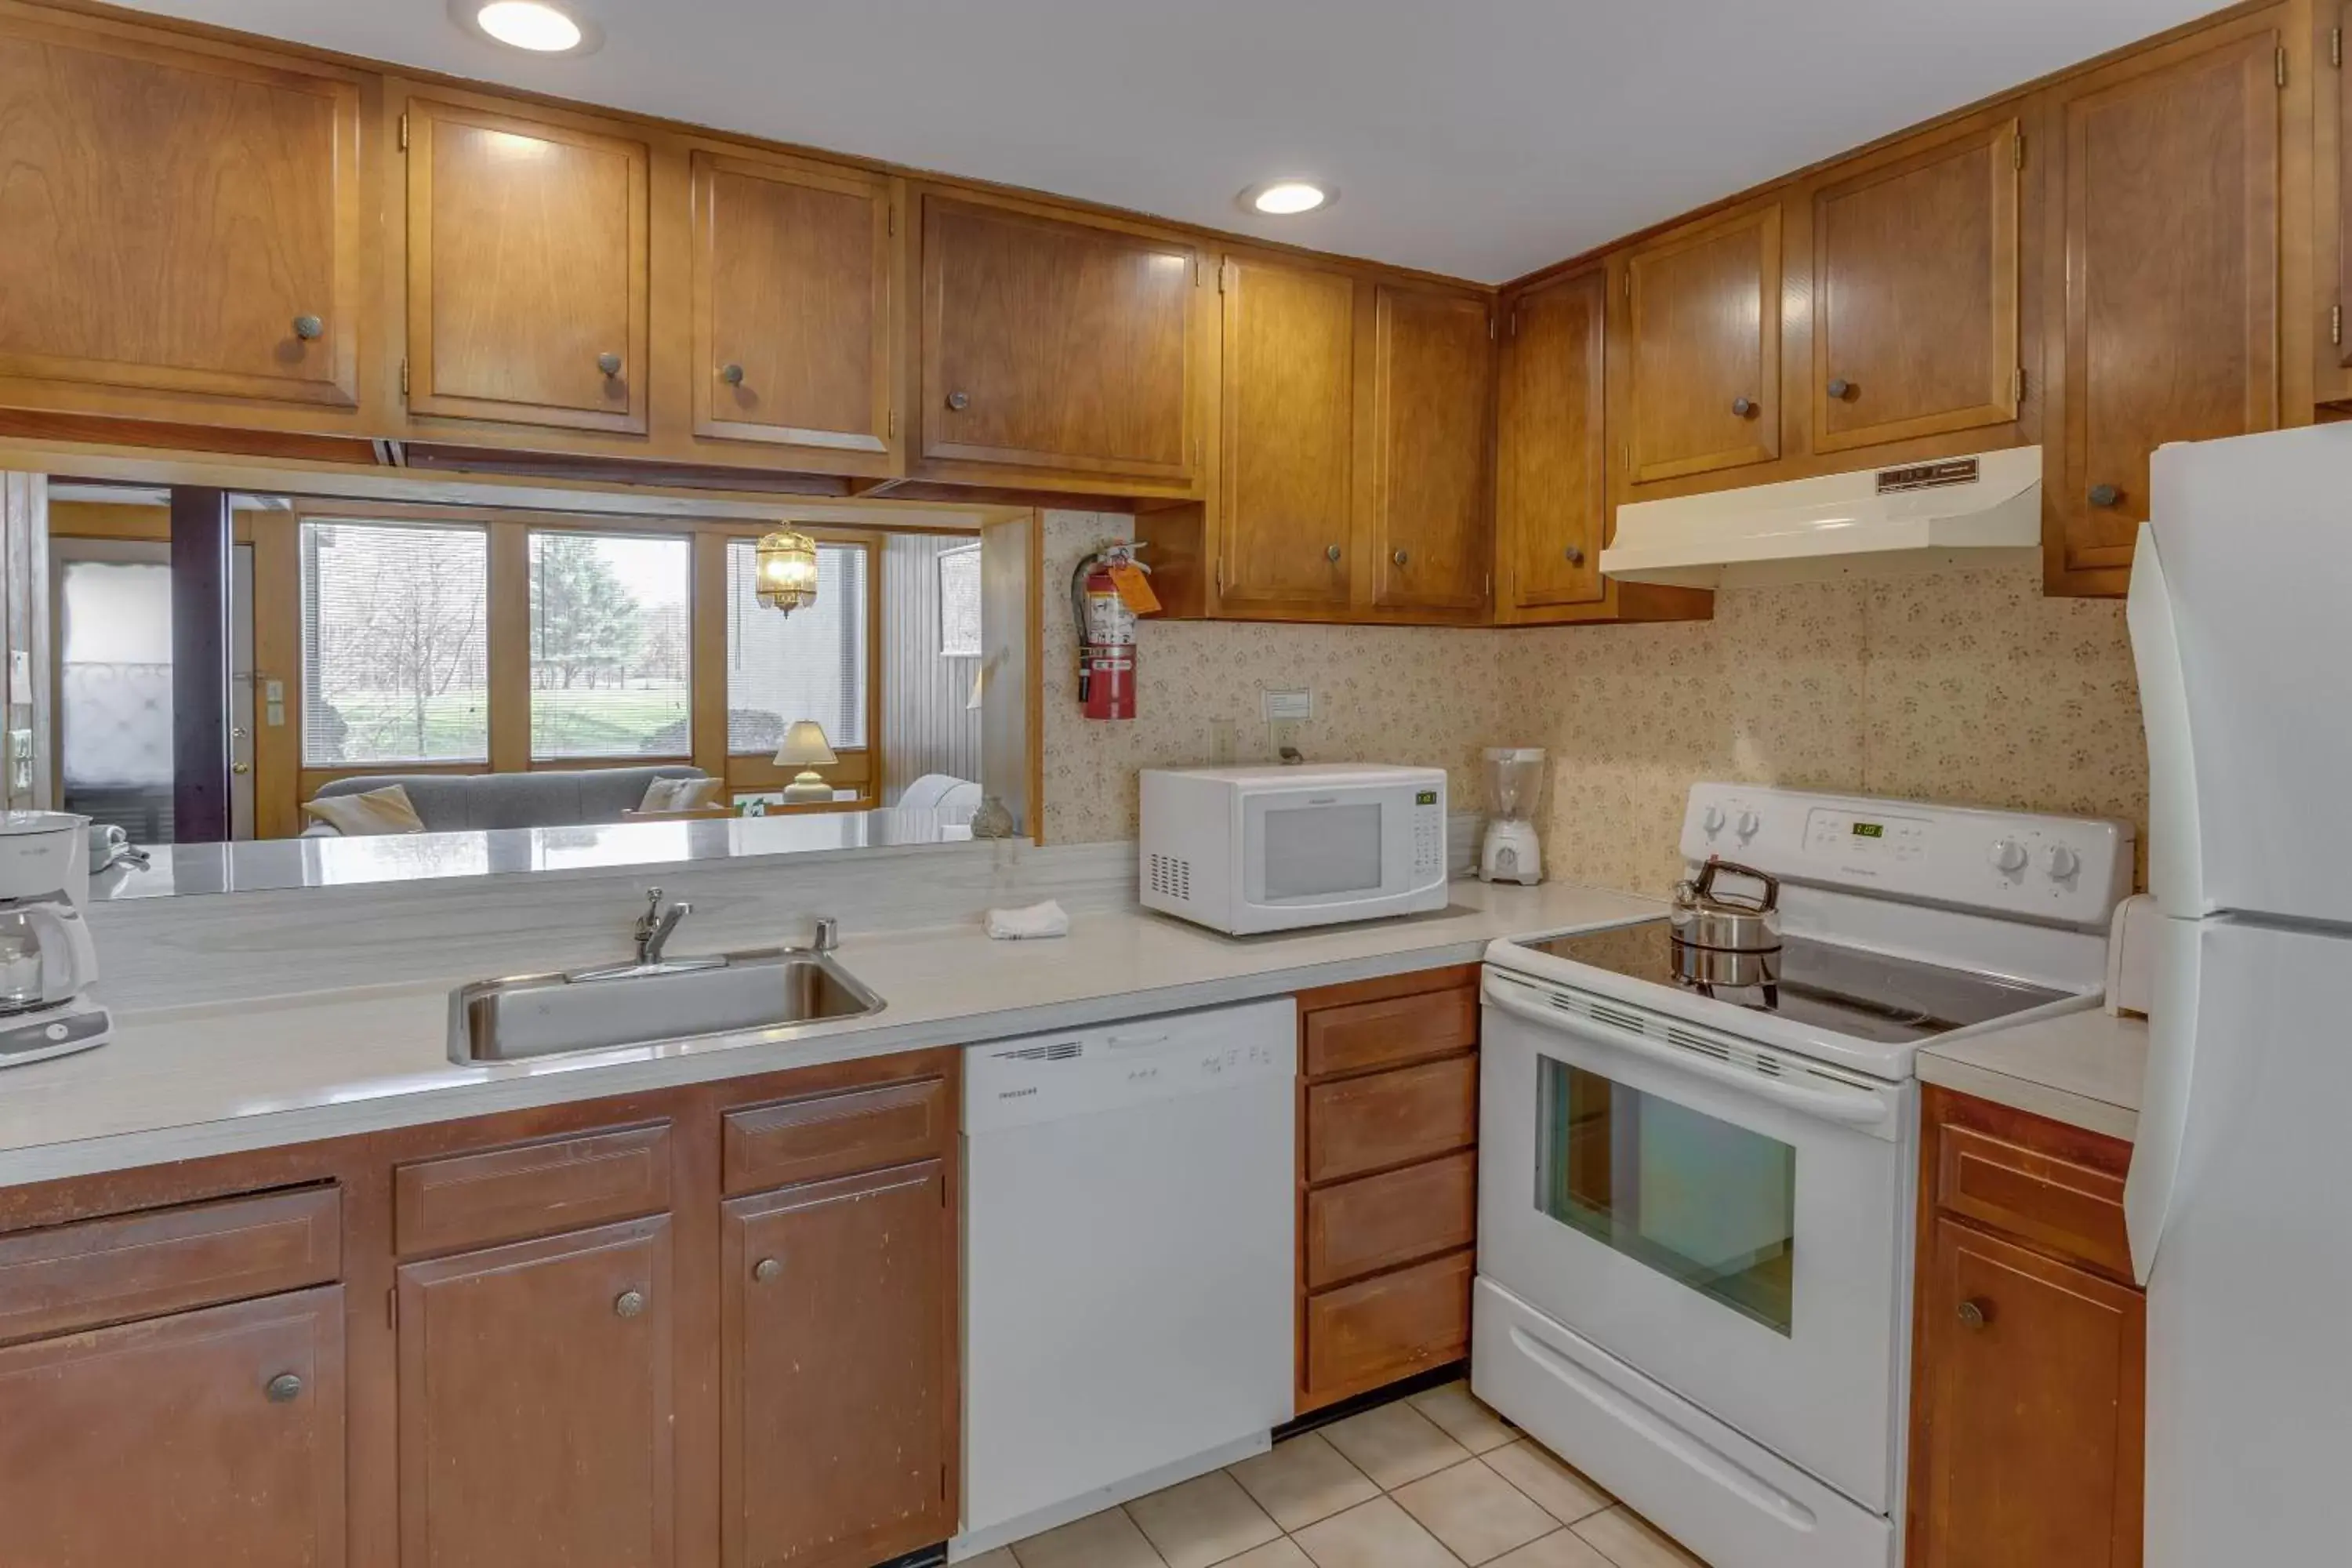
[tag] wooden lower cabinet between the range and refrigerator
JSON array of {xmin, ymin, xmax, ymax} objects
[{"xmin": 1910, "ymin": 1088, "xmax": 2147, "ymax": 1568}]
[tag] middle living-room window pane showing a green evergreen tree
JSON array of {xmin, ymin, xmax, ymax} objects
[{"xmin": 532, "ymin": 532, "xmax": 694, "ymax": 762}]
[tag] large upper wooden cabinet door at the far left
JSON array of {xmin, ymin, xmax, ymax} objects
[{"xmin": 0, "ymin": 12, "xmax": 360, "ymax": 407}]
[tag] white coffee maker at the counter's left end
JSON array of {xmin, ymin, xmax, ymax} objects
[{"xmin": 0, "ymin": 811, "xmax": 113, "ymax": 1067}]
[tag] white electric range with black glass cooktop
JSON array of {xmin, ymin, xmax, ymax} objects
[{"xmin": 1472, "ymin": 783, "xmax": 2131, "ymax": 1568}]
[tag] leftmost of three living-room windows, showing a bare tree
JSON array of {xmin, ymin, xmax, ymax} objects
[{"xmin": 301, "ymin": 522, "xmax": 489, "ymax": 769}]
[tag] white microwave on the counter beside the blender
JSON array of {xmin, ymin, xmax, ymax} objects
[{"xmin": 1138, "ymin": 762, "xmax": 1446, "ymax": 935}]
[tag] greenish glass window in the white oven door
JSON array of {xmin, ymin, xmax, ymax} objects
[{"xmin": 1536, "ymin": 1058, "xmax": 1797, "ymax": 1335}]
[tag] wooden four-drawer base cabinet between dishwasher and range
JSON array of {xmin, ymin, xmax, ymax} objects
[{"xmin": 1298, "ymin": 964, "xmax": 1479, "ymax": 1415}]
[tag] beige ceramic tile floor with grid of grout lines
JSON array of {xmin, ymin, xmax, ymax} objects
[{"xmin": 962, "ymin": 1382, "xmax": 1705, "ymax": 1568}]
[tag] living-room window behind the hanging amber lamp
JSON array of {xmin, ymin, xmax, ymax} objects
[{"xmin": 727, "ymin": 539, "xmax": 870, "ymax": 757}]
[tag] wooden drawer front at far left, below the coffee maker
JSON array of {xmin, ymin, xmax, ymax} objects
[{"xmin": 0, "ymin": 1187, "xmax": 343, "ymax": 1342}]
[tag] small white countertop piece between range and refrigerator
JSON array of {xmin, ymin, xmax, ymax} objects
[{"xmin": 1919, "ymin": 1008, "xmax": 2147, "ymax": 1140}]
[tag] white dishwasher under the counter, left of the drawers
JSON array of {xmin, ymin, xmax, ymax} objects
[{"xmin": 950, "ymin": 996, "xmax": 1298, "ymax": 1559}]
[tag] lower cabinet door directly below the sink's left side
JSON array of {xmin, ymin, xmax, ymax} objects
[{"xmin": 397, "ymin": 1215, "xmax": 673, "ymax": 1568}]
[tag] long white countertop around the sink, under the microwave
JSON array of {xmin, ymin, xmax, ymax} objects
[{"xmin": 0, "ymin": 881, "xmax": 1661, "ymax": 1185}]
